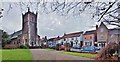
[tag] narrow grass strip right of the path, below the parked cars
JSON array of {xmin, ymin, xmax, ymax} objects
[{"xmin": 61, "ymin": 52, "xmax": 96, "ymax": 59}]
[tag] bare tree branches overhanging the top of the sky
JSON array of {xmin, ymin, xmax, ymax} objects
[{"xmin": 2, "ymin": 0, "xmax": 120, "ymax": 27}]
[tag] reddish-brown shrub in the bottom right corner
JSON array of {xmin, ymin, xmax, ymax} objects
[{"xmin": 96, "ymin": 43, "xmax": 118, "ymax": 60}]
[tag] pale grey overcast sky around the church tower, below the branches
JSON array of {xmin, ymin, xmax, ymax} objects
[{"xmin": 0, "ymin": 2, "xmax": 117, "ymax": 37}]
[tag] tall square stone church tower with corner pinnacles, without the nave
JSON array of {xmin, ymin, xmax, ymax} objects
[{"xmin": 22, "ymin": 8, "xmax": 37, "ymax": 47}]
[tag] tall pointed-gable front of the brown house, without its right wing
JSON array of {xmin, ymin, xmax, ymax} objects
[{"xmin": 97, "ymin": 22, "xmax": 109, "ymax": 47}]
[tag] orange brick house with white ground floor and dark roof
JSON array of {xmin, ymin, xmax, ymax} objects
[{"xmin": 83, "ymin": 30, "xmax": 96, "ymax": 46}]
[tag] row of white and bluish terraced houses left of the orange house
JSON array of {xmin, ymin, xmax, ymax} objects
[{"xmin": 48, "ymin": 32, "xmax": 83, "ymax": 49}]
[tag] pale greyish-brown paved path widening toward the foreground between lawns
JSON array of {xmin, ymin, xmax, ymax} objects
[{"xmin": 30, "ymin": 49, "xmax": 93, "ymax": 60}]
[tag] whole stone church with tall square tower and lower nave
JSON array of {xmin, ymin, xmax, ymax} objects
[{"xmin": 9, "ymin": 8, "xmax": 40, "ymax": 47}]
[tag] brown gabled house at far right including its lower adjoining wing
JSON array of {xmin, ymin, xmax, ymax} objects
[{"xmin": 97, "ymin": 22, "xmax": 120, "ymax": 47}]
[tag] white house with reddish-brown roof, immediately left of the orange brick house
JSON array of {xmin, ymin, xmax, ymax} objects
[{"xmin": 61, "ymin": 31, "xmax": 83, "ymax": 48}]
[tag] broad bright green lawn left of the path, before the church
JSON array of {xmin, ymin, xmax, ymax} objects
[{"xmin": 0, "ymin": 49, "xmax": 32, "ymax": 60}]
